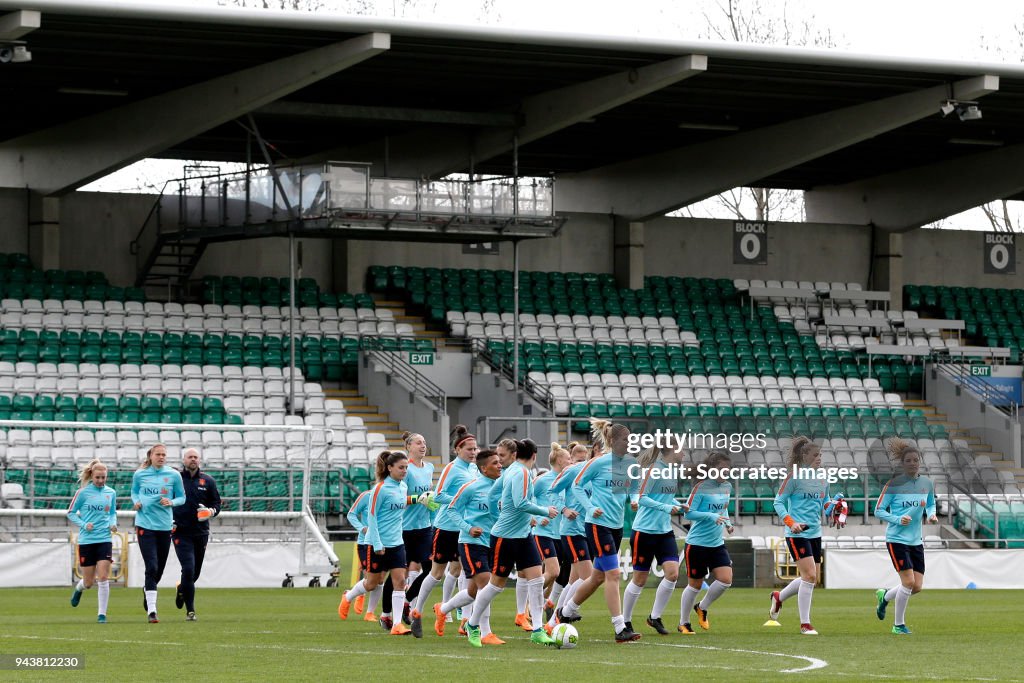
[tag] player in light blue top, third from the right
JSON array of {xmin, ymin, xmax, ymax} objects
[{"xmin": 675, "ymin": 451, "xmax": 733, "ymax": 635}]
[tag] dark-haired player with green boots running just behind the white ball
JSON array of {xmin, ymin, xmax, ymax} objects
[{"xmin": 466, "ymin": 440, "xmax": 558, "ymax": 647}]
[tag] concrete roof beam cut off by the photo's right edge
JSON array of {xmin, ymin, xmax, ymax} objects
[{"xmin": 804, "ymin": 144, "xmax": 1024, "ymax": 231}]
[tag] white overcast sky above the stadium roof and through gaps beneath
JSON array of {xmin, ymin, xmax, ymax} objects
[{"xmin": 83, "ymin": 0, "xmax": 1024, "ymax": 229}]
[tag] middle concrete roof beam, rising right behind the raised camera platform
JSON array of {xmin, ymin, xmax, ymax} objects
[{"xmin": 306, "ymin": 54, "xmax": 708, "ymax": 178}]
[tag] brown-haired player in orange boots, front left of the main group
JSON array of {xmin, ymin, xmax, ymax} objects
[{"xmin": 338, "ymin": 451, "xmax": 412, "ymax": 636}]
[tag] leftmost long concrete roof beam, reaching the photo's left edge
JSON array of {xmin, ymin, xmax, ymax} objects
[{"xmin": 0, "ymin": 33, "xmax": 391, "ymax": 195}]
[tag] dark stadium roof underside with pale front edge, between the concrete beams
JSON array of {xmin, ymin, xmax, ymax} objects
[{"xmin": 0, "ymin": 0, "xmax": 1024, "ymax": 198}]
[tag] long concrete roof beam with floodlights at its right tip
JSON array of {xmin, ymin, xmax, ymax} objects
[{"xmin": 555, "ymin": 76, "xmax": 999, "ymax": 220}]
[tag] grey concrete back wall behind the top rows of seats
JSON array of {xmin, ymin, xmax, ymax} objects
[{"xmin": 6, "ymin": 189, "xmax": 1024, "ymax": 291}]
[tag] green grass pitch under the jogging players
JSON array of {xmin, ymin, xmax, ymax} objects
[{"xmin": 0, "ymin": 588, "xmax": 1024, "ymax": 683}]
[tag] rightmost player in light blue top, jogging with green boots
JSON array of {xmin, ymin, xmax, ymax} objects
[{"xmin": 874, "ymin": 438, "xmax": 939, "ymax": 635}]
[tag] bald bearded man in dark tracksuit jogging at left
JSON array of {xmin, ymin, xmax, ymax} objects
[{"xmin": 171, "ymin": 449, "xmax": 220, "ymax": 622}]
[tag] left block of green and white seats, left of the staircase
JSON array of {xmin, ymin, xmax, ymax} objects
[{"xmin": 0, "ymin": 254, "xmax": 433, "ymax": 512}]
